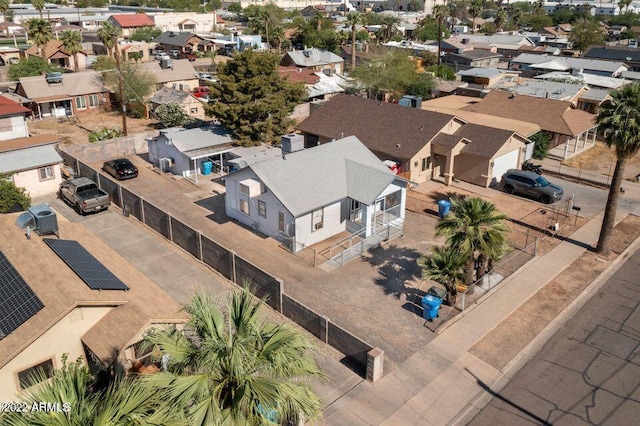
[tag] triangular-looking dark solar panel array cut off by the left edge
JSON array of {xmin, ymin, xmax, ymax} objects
[{"xmin": 0, "ymin": 252, "xmax": 44, "ymax": 340}]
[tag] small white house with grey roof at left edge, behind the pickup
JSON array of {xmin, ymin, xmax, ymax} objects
[{"xmin": 0, "ymin": 135, "xmax": 62, "ymax": 198}]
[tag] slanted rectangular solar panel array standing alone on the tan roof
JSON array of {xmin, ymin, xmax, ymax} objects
[{"xmin": 44, "ymin": 238, "xmax": 129, "ymax": 290}]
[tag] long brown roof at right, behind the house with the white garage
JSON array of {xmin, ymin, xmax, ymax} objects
[{"xmin": 464, "ymin": 90, "xmax": 595, "ymax": 136}]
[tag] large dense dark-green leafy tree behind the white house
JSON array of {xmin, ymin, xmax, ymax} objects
[{"xmin": 205, "ymin": 49, "xmax": 307, "ymax": 145}]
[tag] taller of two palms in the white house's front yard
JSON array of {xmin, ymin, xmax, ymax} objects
[{"xmin": 436, "ymin": 197, "xmax": 509, "ymax": 290}]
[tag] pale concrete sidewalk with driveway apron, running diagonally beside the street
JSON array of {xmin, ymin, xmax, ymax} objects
[{"xmin": 325, "ymin": 201, "xmax": 640, "ymax": 425}]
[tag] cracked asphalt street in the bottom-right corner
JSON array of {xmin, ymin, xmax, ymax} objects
[{"xmin": 469, "ymin": 251, "xmax": 640, "ymax": 426}]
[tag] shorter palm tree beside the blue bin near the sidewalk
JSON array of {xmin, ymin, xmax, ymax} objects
[{"xmin": 418, "ymin": 247, "xmax": 467, "ymax": 306}]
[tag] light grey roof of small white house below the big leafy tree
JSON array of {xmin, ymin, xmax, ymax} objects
[{"xmin": 156, "ymin": 126, "xmax": 233, "ymax": 158}]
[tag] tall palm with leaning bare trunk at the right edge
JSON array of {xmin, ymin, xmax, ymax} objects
[{"xmin": 596, "ymin": 83, "xmax": 640, "ymax": 254}]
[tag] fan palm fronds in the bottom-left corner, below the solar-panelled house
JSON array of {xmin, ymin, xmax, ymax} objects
[{"xmin": 0, "ymin": 355, "xmax": 187, "ymax": 426}]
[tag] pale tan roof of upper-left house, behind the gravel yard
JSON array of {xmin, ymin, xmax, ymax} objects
[{"xmin": 18, "ymin": 71, "xmax": 109, "ymax": 102}]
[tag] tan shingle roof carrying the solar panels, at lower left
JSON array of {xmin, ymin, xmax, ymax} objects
[{"xmin": 0, "ymin": 214, "xmax": 184, "ymax": 368}]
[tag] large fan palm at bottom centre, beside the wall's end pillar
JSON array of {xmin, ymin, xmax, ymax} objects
[{"xmin": 145, "ymin": 288, "xmax": 323, "ymax": 425}]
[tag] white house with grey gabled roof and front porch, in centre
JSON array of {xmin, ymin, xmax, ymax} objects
[{"xmin": 225, "ymin": 136, "xmax": 407, "ymax": 252}]
